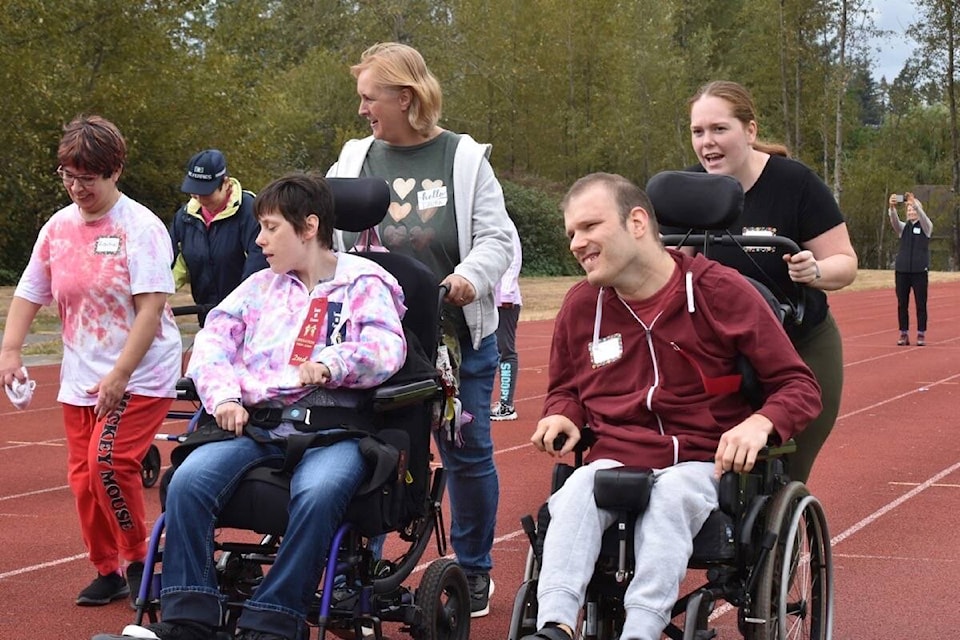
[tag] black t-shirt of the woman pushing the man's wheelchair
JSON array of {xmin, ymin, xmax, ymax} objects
[{"xmin": 661, "ymin": 155, "xmax": 844, "ymax": 341}]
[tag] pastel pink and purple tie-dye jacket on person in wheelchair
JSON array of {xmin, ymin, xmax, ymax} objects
[{"xmin": 187, "ymin": 253, "xmax": 407, "ymax": 412}]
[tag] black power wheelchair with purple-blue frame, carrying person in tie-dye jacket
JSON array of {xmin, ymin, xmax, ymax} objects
[{"xmin": 107, "ymin": 178, "xmax": 470, "ymax": 640}]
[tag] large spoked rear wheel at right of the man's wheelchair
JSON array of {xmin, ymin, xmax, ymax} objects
[{"xmin": 744, "ymin": 482, "xmax": 833, "ymax": 640}]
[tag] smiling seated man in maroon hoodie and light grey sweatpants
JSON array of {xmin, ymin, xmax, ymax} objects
[{"xmin": 528, "ymin": 173, "xmax": 821, "ymax": 640}]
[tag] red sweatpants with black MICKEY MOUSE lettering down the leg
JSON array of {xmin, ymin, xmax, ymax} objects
[{"xmin": 63, "ymin": 393, "xmax": 173, "ymax": 575}]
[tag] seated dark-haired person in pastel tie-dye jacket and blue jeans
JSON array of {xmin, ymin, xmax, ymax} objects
[{"xmin": 100, "ymin": 174, "xmax": 406, "ymax": 640}]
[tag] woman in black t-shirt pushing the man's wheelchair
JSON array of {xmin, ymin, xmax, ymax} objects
[{"xmin": 689, "ymin": 81, "xmax": 857, "ymax": 481}]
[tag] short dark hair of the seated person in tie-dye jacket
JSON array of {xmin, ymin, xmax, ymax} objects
[{"xmin": 253, "ymin": 171, "xmax": 335, "ymax": 247}]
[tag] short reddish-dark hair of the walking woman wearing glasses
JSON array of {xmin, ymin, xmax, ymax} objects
[{"xmin": 57, "ymin": 115, "xmax": 127, "ymax": 178}]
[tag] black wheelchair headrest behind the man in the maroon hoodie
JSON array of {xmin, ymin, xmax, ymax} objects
[{"xmin": 647, "ymin": 171, "xmax": 743, "ymax": 231}]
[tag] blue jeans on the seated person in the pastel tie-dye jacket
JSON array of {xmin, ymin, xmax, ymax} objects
[{"xmin": 160, "ymin": 436, "xmax": 366, "ymax": 639}]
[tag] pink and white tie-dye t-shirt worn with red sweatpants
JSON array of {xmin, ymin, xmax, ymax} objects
[{"xmin": 15, "ymin": 195, "xmax": 181, "ymax": 406}]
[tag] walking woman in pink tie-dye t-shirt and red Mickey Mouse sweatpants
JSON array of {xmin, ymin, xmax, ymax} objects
[{"xmin": 0, "ymin": 116, "xmax": 181, "ymax": 606}]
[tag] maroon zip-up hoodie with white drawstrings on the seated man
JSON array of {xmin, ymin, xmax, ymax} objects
[{"xmin": 543, "ymin": 249, "xmax": 821, "ymax": 469}]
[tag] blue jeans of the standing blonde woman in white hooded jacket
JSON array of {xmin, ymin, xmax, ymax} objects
[{"xmin": 436, "ymin": 334, "xmax": 500, "ymax": 575}]
